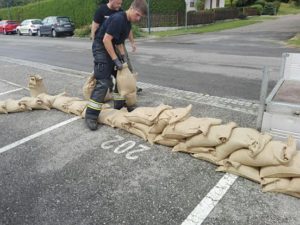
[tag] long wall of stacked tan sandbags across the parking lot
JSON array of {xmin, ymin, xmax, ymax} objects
[{"xmin": 0, "ymin": 74, "xmax": 300, "ymax": 198}]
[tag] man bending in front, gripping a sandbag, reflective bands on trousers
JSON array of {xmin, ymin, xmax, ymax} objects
[{"xmin": 85, "ymin": 0, "xmax": 147, "ymax": 130}]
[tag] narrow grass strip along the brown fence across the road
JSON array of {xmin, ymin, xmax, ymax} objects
[{"xmin": 145, "ymin": 18, "xmax": 262, "ymax": 37}]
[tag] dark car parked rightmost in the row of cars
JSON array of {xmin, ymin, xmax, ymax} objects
[{"xmin": 37, "ymin": 16, "xmax": 75, "ymax": 37}]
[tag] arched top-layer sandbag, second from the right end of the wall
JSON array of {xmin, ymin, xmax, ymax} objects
[{"xmin": 216, "ymin": 127, "xmax": 272, "ymax": 160}]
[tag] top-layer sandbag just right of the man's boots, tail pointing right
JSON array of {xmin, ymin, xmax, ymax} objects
[{"xmin": 126, "ymin": 104, "xmax": 172, "ymax": 126}]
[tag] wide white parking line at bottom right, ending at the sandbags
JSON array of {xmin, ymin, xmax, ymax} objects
[{"xmin": 181, "ymin": 173, "xmax": 238, "ymax": 225}]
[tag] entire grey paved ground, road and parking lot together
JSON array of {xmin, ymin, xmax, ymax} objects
[{"xmin": 0, "ymin": 15, "xmax": 300, "ymax": 225}]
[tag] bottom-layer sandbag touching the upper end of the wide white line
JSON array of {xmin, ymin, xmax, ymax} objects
[{"xmin": 216, "ymin": 160, "xmax": 261, "ymax": 183}]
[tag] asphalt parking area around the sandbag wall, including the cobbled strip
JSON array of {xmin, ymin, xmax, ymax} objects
[{"xmin": 0, "ymin": 55, "xmax": 300, "ymax": 225}]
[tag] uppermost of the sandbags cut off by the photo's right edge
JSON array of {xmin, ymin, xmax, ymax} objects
[{"xmin": 260, "ymin": 151, "xmax": 300, "ymax": 178}]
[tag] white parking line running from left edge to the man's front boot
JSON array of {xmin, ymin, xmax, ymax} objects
[{"xmin": 0, "ymin": 116, "xmax": 81, "ymax": 154}]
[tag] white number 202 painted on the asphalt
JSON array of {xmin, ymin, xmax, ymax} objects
[{"xmin": 101, "ymin": 135, "xmax": 151, "ymax": 160}]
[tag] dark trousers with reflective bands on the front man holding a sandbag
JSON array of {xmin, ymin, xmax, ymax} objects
[{"xmin": 85, "ymin": 41, "xmax": 125, "ymax": 120}]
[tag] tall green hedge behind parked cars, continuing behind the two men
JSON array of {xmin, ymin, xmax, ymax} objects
[{"xmin": 0, "ymin": 0, "xmax": 185, "ymax": 28}]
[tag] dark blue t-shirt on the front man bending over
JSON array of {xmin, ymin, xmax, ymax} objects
[{"xmin": 95, "ymin": 12, "xmax": 131, "ymax": 45}]
